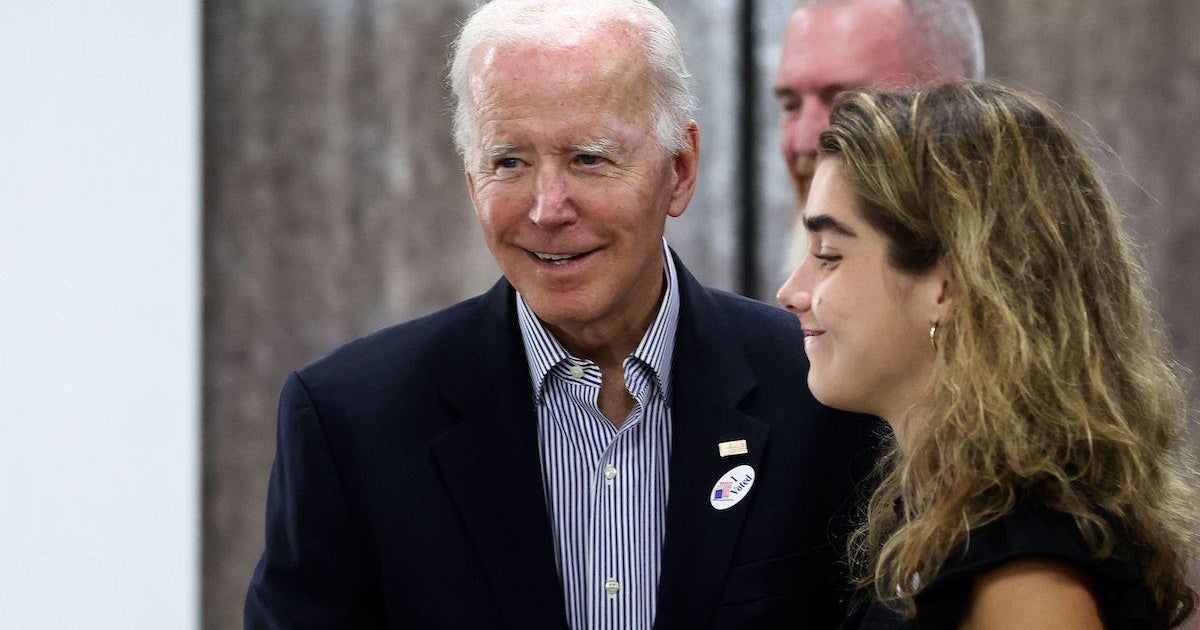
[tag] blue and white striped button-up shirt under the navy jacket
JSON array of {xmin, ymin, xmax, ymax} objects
[{"xmin": 517, "ymin": 241, "xmax": 679, "ymax": 630}]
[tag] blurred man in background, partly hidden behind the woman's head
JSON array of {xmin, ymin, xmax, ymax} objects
[{"xmin": 775, "ymin": 0, "xmax": 983, "ymax": 265}]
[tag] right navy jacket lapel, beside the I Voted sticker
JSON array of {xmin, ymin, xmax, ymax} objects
[{"xmin": 655, "ymin": 262, "xmax": 769, "ymax": 630}]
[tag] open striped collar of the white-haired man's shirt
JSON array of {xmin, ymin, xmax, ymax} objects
[{"xmin": 517, "ymin": 239, "xmax": 679, "ymax": 402}]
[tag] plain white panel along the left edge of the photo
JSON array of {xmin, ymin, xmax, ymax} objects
[{"xmin": 0, "ymin": 0, "xmax": 200, "ymax": 629}]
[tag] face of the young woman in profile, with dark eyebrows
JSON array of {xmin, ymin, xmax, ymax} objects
[{"xmin": 776, "ymin": 158, "xmax": 948, "ymax": 427}]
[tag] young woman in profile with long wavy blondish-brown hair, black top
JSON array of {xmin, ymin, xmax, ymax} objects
[{"xmin": 779, "ymin": 84, "xmax": 1200, "ymax": 629}]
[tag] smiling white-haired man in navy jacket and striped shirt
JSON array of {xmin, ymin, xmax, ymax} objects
[{"xmin": 246, "ymin": 0, "xmax": 872, "ymax": 630}]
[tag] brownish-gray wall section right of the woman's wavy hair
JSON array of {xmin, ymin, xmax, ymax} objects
[{"xmin": 974, "ymin": 0, "xmax": 1200, "ymax": 407}]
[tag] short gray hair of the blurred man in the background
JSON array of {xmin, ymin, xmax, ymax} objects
[{"xmin": 797, "ymin": 0, "xmax": 984, "ymax": 80}]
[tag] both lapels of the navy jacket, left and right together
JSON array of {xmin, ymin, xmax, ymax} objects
[{"xmin": 432, "ymin": 260, "xmax": 769, "ymax": 630}]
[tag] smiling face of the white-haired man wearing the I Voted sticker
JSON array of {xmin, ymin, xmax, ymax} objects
[{"xmin": 466, "ymin": 31, "xmax": 696, "ymax": 350}]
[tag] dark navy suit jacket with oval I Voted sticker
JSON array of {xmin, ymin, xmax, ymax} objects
[{"xmin": 245, "ymin": 256, "xmax": 878, "ymax": 630}]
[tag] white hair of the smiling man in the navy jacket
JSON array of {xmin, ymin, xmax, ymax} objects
[{"xmin": 449, "ymin": 0, "xmax": 696, "ymax": 156}]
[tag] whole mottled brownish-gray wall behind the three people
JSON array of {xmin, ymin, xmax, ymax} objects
[{"xmin": 203, "ymin": 0, "xmax": 1200, "ymax": 629}]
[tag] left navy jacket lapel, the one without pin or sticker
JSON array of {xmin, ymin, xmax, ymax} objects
[{"xmin": 432, "ymin": 281, "xmax": 566, "ymax": 629}]
